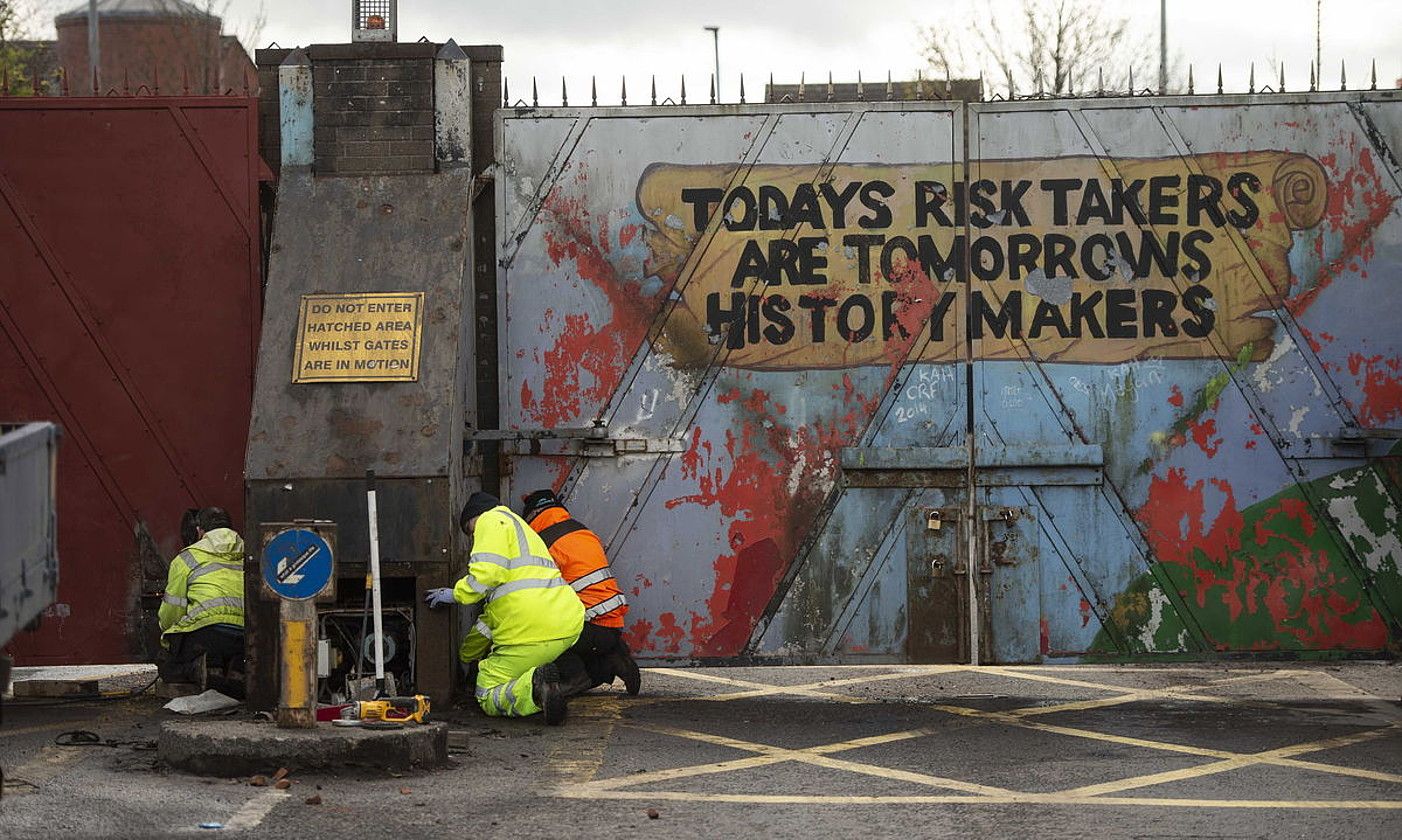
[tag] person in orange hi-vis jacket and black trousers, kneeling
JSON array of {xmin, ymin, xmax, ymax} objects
[{"xmin": 522, "ymin": 489, "xmax": 642, "ymax": 694}]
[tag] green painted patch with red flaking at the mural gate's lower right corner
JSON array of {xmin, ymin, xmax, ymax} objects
[{"xmin": 1091, "ymin": 446, "xmax": 1402, "ymax": 656}]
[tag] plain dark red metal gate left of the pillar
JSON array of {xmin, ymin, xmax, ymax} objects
[{"xmin": 0, "ymin": 97, "xmax": 261, "ymax": 663}]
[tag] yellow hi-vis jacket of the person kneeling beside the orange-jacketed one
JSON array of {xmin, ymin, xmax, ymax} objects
[{"xmin": 453, "ymin": 505, "xmax": 585, "ymax": 662}]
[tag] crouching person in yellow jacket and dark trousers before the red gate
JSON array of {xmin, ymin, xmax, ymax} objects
[{"xmin": 157, "ymin": 508, "xmax": 244, "ymax": 700}]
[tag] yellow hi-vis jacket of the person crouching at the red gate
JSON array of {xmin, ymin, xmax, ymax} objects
[{"xmin": 157, "ymin": 527, "xmax": 244, "ymax": 634}]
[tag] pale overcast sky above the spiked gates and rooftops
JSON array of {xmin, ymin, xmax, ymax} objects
[{"xmin": 29, "ymin": 0, "xmax": 1402, "ymax": 104}]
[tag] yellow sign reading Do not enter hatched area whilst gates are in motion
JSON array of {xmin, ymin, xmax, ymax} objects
[{"xmin": 292, "ymin": 292, "xmax": 423, "ymax": 381}]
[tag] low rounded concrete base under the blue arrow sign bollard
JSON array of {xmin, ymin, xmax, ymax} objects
[{"xmin": 156, "ymin": 721, "xmax": 447, "ymax": 775}]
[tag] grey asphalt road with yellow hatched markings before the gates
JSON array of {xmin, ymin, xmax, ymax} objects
[{"xmin": 0, "ymin": 663, "xmax": 1402, "ymax": 840}]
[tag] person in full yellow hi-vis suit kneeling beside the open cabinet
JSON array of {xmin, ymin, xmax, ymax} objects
[{"xmin": 425, "ymin": 492, "xmax": 585, "ymax": 726}]
